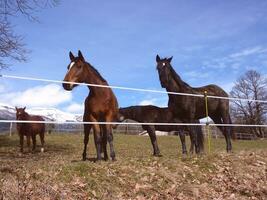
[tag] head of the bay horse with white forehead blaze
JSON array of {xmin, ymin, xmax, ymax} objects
[{"xmin": 62, "ymin": 50, "xmax": 87, "ymax": 90}]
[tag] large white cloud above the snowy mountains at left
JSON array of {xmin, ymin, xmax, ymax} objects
[{"xmin": 0, "ymin": 84, "xmax": 72, "ymax": 107}]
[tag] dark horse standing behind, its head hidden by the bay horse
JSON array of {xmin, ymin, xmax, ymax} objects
[{"xmin": 119, "ymin": 105, "xmax": 194, "ymax": 156}]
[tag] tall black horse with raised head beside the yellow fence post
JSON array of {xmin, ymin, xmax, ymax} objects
[{"xmin": 156, "ymin": 55, "xmax": 234, "ymax": 151}]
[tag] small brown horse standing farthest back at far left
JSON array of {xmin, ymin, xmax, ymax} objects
[{"xmin": 16, "ymin": 107, "xmax": 45, "ymax": 152}]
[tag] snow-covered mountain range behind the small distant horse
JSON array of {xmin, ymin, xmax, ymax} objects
[{"xmin": 0, "ymin": 104, "xmax": 82, "ymax": 122}]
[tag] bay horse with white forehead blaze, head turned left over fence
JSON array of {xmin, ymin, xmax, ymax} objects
[{"xmin": 63, "ymin": 50, "xmax": 118, "ymax": 160}]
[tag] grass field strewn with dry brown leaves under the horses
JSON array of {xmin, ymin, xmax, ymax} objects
[{"xmin": 0, "ymin": 134, "xmax": 267, "ymax": 199}]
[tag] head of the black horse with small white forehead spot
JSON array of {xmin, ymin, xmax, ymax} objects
[{"xmin": 156, "ymin": 55, "xmax": 172, "ymax": 88}]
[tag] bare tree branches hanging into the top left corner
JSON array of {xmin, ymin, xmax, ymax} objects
[{"xmin": 0, "ymin": 0, "xmax": 59, "ymax": 69}]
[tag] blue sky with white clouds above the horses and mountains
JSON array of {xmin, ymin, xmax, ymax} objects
[{"xmin": 0, "ymin": 0, "xmax": 267, "ymax": 113}]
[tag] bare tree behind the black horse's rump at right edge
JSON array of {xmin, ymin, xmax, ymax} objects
[{"xmin": 230, "ymin": 70, "xmax": 267, "ymax": 137}]
